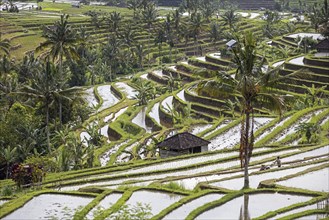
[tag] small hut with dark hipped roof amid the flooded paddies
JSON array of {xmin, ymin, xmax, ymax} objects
[{"xmin": 157, "ymin": 132, "xmax": 210, "ymax": 158}]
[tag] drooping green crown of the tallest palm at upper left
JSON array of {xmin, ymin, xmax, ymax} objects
[{"xmin": 36, "ymin": 14, "xmax": 79, "ymax": 72}]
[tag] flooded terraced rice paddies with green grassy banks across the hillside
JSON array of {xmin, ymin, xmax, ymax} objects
[{"xmin": 0, "ymin": 3, "xmax": 329, "ymax": 220}]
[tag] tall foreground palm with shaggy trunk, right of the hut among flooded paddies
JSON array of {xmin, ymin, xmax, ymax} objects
[{"xmin": 199, "ymin": 32, "xmax": 284, "ymax": 188}]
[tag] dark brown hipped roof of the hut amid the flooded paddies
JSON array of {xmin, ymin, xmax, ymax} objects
[{"xmin": 157, "ymin": 132, "xmax": 210, "ymax": 150}]
